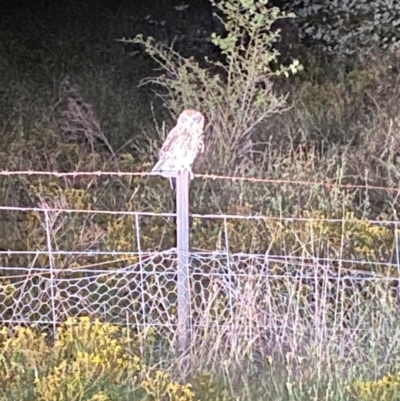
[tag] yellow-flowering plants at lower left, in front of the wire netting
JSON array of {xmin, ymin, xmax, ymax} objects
[{"xmin": 0, "ymin": 317, "xmax": 231, "ymax": 401}]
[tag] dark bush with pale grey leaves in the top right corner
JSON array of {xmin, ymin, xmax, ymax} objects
[{"xmin": 287, "ymin": 0, "xmax": 400, "ymax": 55}]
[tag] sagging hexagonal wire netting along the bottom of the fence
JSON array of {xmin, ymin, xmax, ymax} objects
[{"xmin": 0, "ymin": 250, "xmax": 399, "ymax": 354}]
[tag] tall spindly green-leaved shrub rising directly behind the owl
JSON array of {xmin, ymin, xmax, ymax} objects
[{"xmin": 127, "ymin": 0, "xmax": 301, "ymax": 173}]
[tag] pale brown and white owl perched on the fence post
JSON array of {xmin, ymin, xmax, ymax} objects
[{"xmin": 152, "ymin": 109, "xmax": 205, "ymax": 188}]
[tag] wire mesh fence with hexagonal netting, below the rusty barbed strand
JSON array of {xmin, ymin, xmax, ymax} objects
[{"xmin": 0, "ymin": 172, "xmax": 400, "ymax": 356}]
